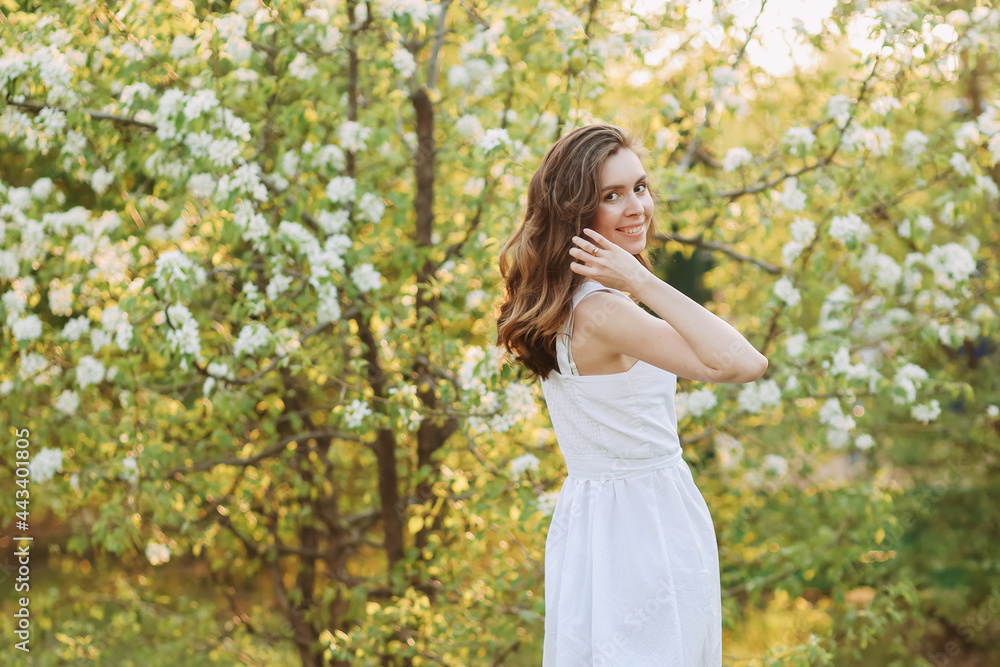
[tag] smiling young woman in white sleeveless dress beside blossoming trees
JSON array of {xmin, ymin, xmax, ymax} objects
[{"xmin": 497, "ymin": 124, "xmax": 767, "ymax": 667}]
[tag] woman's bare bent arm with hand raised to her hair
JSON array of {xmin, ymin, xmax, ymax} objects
[{"xmin": 570, "ymin": 229, "xmax": 767, "ymax": 383}]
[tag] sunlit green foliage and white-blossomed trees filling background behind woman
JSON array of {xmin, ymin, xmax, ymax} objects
[{"xmin": 0, "ymin": 0, "xmax": 1000, "ymax": 666}]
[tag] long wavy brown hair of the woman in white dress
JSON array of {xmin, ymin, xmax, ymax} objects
[{"xmin": 496, "ymin": 123, "xmax": 657, "ymax": 379}]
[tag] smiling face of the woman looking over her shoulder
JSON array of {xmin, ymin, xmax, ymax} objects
[{"xmin": 591, "ymin": 149, "xmax": 653, "ymax": 255}]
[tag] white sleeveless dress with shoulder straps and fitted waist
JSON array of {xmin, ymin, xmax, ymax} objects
[{"xmin": 542, "ymin": 281, "xmax": 722, "ymax": 667}]
